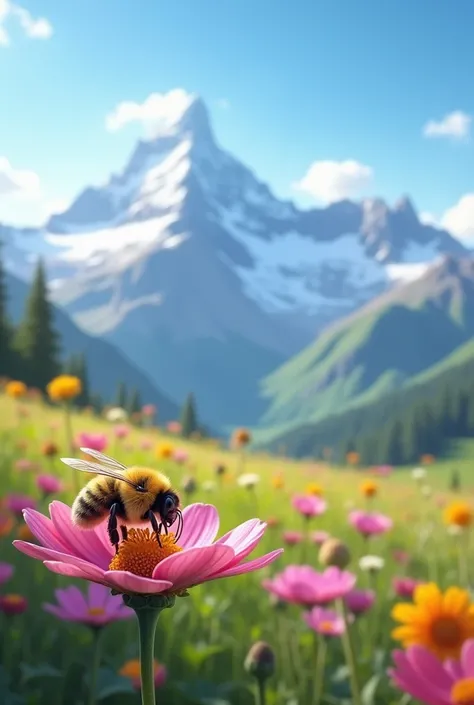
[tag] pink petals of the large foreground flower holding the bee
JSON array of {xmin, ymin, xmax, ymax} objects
[{"xmin": 13, "ymin": 501, "xmax": 283, "ymax": 595}]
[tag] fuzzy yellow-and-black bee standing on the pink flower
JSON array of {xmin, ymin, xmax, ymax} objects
[{"xmin": 61, "ymin": 448, "xmax": 183, "ymax": 553}]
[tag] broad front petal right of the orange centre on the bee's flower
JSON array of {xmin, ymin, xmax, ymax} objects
[{"xmin": 153, "ymin": 543, "xmax": 234, "ymax": 590}]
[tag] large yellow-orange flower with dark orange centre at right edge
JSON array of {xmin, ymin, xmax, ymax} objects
[{"xmin": 392, "ymin": 583, "xmax": 474, "ymax": 660}]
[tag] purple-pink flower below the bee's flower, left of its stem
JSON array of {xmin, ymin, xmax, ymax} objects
[{"xmin": 43, "ymin": 583, "xmax": 134, "ymax": 627}]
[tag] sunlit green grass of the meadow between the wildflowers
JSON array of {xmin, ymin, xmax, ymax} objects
[{"xmin": 0, "ymin": 395, "xmax": 474, "ymax": 705}]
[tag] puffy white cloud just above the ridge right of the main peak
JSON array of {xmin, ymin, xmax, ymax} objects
[{"xmin": 293, "ymin": 159, "xmax": 374, "ymax": 203}]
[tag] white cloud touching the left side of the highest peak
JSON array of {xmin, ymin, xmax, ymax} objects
[{"xmin": 106, "ymin": 88, "xmax": 194, "ymax": 132}]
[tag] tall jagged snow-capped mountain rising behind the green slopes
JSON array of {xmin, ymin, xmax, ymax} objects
[{"xmin": 0, "ymin": 91, "xmax": 466, "ymax": 424}]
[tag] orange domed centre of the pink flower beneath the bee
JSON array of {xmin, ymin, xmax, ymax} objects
[{"xmin": 109, "ymin": 529, "xmax": 183, "ymax": 578}]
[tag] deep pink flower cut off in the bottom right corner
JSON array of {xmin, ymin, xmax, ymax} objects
[{"xmin": 389, "ymin": 639, "xmax": 474, "ymax": 705}]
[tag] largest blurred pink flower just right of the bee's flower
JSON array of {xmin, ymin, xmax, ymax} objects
[{"xmin": 262, "ymin": 565, "xmax": 356, "ymax": 606}]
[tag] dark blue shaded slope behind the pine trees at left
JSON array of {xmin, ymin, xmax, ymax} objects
[{"xmin": 6, "ymin": 274, "xmax": 179, "ymax": 423}]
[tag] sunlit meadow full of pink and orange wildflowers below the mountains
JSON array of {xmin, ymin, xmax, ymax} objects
[{"xmin": 0, "ymin": 384, "xmax": 474, "ymax": 705}]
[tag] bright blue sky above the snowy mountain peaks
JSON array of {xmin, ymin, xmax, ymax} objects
[{"xmin": 0, "ymin": 0, "xmax": 474, "ymax": 236}]
